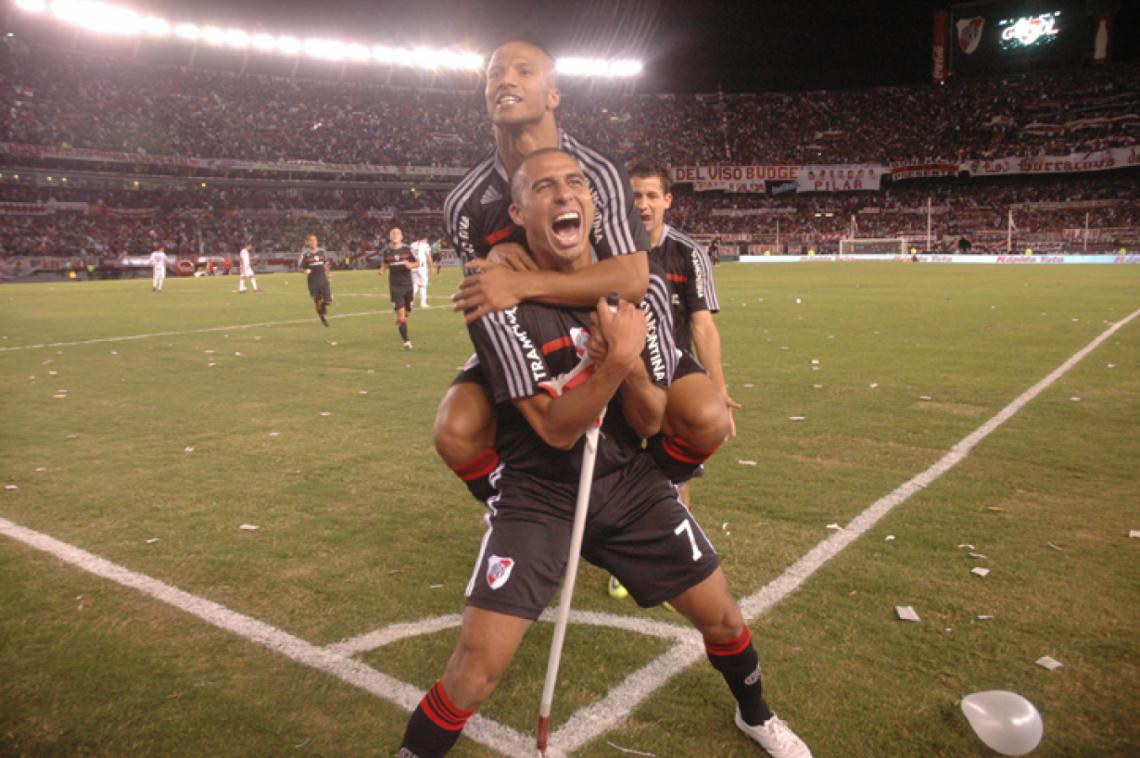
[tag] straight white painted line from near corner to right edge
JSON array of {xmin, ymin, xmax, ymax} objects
[{"xmin": 549, "ymin": 309, "xmax": 1140, "ymax": 752}]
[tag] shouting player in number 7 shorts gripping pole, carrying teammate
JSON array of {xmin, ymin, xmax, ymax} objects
[{"xmin": 399, "ymin": 148, "xmax": 811, "ymax": 758}]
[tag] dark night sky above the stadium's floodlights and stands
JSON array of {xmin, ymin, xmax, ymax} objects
[{"xmin": 129, "ymin": 0, "xmax": 1140, "ymax": 92}]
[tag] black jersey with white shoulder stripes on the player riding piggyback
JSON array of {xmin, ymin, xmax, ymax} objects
[{"xmin": 443, "ymin": 130, "xmax": 649, "ymax": 262}]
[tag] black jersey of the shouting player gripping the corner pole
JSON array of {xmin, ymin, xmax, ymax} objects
[{"xmin": 469, "ymin": 280, "xmax": 677, "ymax": 482}]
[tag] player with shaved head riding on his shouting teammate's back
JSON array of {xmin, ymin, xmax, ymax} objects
[{"xmin": 434, "ymin": 41, "xmax": 728, "ymax": 500}]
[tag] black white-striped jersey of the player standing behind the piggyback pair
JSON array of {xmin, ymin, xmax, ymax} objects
[{"xmin": 650, "ymin": 225, "xmax": 720, "ymax": 350}]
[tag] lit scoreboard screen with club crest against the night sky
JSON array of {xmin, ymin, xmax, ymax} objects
[{"xmin": 950, "ymin": 0, "xmax": 1089, "ymax": 74}]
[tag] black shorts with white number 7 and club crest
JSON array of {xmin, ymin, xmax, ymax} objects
[{"xmin": 466, "ymin": 454, "xmax": 719, "ymax": 619}]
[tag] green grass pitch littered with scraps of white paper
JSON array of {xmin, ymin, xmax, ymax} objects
[{"xmin": 0, "ymin": 263, "xmax": 1140, "ymax": 758}]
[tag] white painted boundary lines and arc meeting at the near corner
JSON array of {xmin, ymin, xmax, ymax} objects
[{"xmin": 0, "ymin": 310, "xmax": 1140, "ymax": 756}]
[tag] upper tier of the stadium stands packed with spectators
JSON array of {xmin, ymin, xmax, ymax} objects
[{"xmin": 0, "ymin": 43, "xmax": 1140, "ymax": 166}]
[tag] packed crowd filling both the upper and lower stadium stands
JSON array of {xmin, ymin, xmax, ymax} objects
[{"xmin": 0, "ymin": 44, "xmax": 1140, "ymax": 260}]
